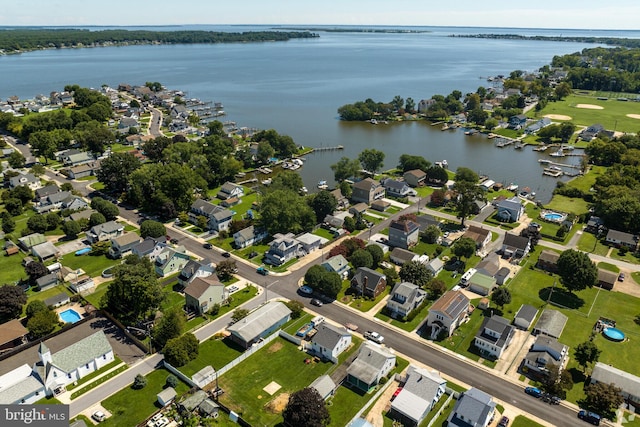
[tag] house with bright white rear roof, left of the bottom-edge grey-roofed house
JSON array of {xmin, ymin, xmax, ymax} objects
[{"xmin": 388, "ymin": 365, "xmax": 447, "ymax": 427}]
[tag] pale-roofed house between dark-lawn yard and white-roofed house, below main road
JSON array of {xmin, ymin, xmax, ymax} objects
[{"xmin": 346, "ymin": 341, "xmax": 396, "ymax": 392}]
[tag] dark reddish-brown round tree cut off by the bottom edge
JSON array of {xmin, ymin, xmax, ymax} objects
[{"xmin": 282, "ymin": 387, "xmax": 331, "ymax": 427}]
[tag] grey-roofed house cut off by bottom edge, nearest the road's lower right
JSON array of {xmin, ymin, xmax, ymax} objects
[{"xmin": 447, "ymin": 388, "xmax": 496, "ymax": 427}]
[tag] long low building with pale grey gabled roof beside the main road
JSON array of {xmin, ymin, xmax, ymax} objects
[{"xmin": 227, "ymin": 301, "xmax": 291, "ymax": 348}]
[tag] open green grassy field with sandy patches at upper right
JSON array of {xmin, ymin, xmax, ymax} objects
[{"xmin": 533, "ymin": 94, "xmax": 640, "ymax": 133}]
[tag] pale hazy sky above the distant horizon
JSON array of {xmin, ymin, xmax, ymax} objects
[{"xmin": 0, "ymin": 0, "xmax": 640, "ymax": 30}]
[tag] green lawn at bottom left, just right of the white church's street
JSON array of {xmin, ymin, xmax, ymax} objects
[{"xmin": 100, "ymin": 369, "xmax": 189, "ymax": 427}]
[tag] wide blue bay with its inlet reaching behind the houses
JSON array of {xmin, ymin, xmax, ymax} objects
[{"xmin": 0, "ymin": 26, "xmax": 640, "ymax": 201}]
